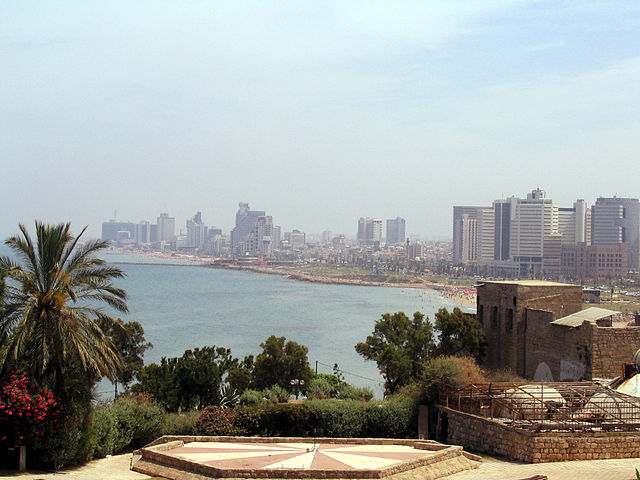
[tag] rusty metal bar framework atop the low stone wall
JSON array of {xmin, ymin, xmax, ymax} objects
[{"xmin": 440, "ymin": 382, "xmax": 640, "ymax": 432}]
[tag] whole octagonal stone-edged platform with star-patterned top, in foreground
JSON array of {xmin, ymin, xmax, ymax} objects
[{"xmin": 131, "ymin": 436, "xmax": 478, "ymax": 480}]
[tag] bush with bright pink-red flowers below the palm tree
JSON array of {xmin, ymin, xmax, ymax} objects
[{"xmin": 0, "ymin": 372, "xmax": 58, "ymax": 447}]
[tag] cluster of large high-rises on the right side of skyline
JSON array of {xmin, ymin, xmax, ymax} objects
[{"xmin": 452, "ymin": 188, "xmax": 640, "ymax": 278}]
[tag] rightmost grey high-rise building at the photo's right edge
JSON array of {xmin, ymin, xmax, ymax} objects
[{"xmin": 591, "ymin": 197, "xmax": 640, "ymax": 270}]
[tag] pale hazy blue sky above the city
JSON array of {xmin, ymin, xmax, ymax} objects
[{"xmin": 0, "ymin": 0, "xmax": 640, "ymax": 238}]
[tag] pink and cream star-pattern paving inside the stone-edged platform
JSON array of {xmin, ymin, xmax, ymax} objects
[{"xmin": 166, "ymin": 442, "xmax": 433, "ymax": 470}]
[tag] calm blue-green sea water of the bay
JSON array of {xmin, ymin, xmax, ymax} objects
[{"xmin": 2, "ymin": 249, "xmax": 468, "ymax": 397}]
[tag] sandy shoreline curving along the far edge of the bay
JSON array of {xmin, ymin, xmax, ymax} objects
[{"xmin": 110, "ymin": 250, "xmax": 476, "ymax": 308}]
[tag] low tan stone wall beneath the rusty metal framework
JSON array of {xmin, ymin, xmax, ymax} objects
[{"xmin": 440, "ymin": 407, "xmax": 640, "ymax": 463}]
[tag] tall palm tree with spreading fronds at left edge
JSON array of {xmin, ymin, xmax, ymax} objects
[{"xmin": 0, "ymin": 221, "xmax": 127, "ymax": 394}]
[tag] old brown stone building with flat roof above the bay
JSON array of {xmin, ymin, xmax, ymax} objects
[{"xmin": 477, "ymin": 280, "xmax": 640, "ymax": 381}]
